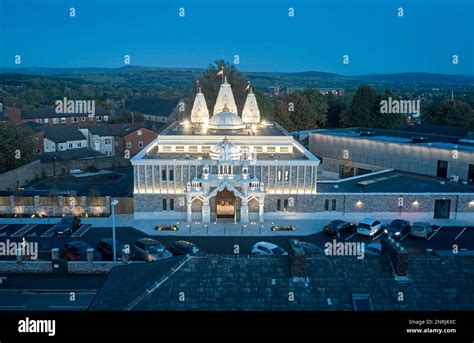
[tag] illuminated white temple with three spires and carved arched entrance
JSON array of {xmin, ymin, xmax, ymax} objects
[{"xmin": 131, "ymin": 80, "xmax": 320, "ymax": 223}]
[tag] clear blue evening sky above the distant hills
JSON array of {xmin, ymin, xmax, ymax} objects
[{"xmin": 0, "ymin": 0, "xmax": 474, "ymax": 75}]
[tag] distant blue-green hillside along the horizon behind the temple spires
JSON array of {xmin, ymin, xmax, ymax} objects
[{"xmin": 0, "ymin": 66, "xmax": 474, "ymax": 90}]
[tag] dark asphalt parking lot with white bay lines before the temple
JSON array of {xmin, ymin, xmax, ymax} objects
[{"xmin": 0, "ymin": 220, "xmax": 474, "ymax": 260}]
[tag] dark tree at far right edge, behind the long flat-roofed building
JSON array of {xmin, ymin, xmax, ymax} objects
[{"xmin": 423, "ymin": 100, "xmax": 474, "ymax": 128}]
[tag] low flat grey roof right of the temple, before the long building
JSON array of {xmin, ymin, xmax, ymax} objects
[{"xmin": 318, "ymin": 170, "xmax": 474, "ymax": 193}]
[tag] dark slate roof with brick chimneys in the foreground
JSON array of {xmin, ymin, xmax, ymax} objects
[{"xmin": 90, "ymin": 255, "xmax": 474, "ymax": 310}]
